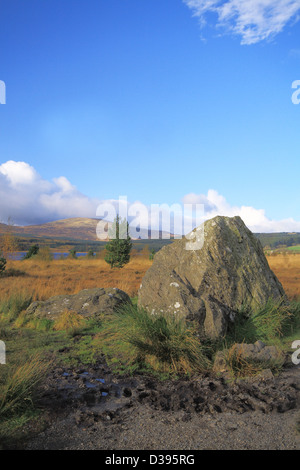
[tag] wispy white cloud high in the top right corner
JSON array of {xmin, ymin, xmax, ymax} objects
[{"xmin": 183, "ymin": 0, "xmax": 300, "ymax": 45}]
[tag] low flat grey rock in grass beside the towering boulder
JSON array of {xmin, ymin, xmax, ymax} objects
[{"xmin": 26, "ymin": 288, "xmax": 131, "ymax": 320}]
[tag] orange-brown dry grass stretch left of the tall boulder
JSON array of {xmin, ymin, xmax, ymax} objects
[{"xmin": 0, "ymin": 256, "xmax": 152, "ymax": 300}]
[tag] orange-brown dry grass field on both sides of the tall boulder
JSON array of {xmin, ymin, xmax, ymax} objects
[{"xmin": 0, "ymin": 254, "xmax": 300, "ymax": 300}]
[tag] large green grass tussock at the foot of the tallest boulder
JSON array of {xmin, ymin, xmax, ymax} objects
[{"xmin": 95, "ymin": 305, "xmax": 210, "ymax": 374}]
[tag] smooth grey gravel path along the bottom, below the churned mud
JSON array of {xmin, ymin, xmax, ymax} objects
[{"xmin": 27, "ymin": 406, "xmax": 300, "ymax": 450}]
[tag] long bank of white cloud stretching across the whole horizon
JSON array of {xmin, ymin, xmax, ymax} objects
[{"xmin": 0, "ymin": 161, "xmax": 300, "ymax": 235}]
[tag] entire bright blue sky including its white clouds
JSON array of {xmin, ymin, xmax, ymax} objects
[{"xmin": 0, "ymin": 0, "xmax": 300, "ymax": 231}]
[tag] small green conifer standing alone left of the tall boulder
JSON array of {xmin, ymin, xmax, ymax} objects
[{"xmin": 104, "ymin": 215, "xmax": 132, "ymax": 268}]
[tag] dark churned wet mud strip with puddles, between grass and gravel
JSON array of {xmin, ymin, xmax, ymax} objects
[{"xmin": 40, "ymin": 363, "xmax": 300, "ymax": 423}]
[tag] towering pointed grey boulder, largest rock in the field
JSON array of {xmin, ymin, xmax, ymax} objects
[{"xmin": 138, "ymin": 216, "xmax": 285, "ymax": 337}]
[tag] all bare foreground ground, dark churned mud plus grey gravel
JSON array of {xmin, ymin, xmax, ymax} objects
[{"xmin": 14, "ymin": 360, "xmax": 300, "ymax": 450}]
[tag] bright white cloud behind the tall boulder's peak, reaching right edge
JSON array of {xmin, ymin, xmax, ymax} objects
[{"xmin": 183, "ymin": 189, "xmax": 300, "ymax": 233}]
